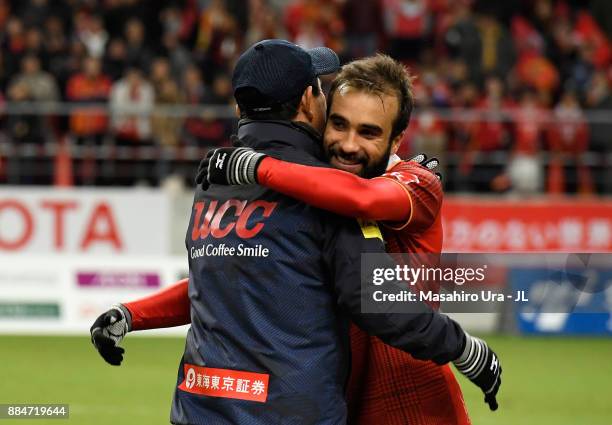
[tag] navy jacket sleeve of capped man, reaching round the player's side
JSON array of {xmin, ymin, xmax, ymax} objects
[{"xmin": 325, "ymin": 218, "xmax": 465, "ymax": 364}]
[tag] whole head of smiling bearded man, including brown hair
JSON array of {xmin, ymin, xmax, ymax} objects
[{"xmin": 323, "ymin": 54, "xmax": 414, "ymax": 178}]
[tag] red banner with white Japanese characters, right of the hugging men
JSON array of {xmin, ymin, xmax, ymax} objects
[{"xmin": 442, "ymin": 197, "xmax": 612, "ymax": 252}]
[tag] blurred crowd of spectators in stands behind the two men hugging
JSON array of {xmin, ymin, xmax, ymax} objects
[{"xmin": 0, "ymin": 0, "xmax": 612, "ymax": 194}]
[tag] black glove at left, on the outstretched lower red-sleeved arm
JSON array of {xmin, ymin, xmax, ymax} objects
[{"xmin": 90, "ymin": 304, "xmax": 132, "ymax": 366}]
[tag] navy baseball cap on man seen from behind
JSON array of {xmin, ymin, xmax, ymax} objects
[{"xmin": 232, "ymin": 39, "xmax": 340, "ymax": 111}]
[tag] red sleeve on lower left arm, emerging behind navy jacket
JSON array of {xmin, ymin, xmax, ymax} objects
[{"xmin": 123, "ymin": 279, "xmax": 191, "ymax": 331}]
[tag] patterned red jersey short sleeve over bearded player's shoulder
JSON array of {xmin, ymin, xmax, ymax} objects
[{"xmin": 382, "ymin": 161, "xmax": 444, "ymax": 233}]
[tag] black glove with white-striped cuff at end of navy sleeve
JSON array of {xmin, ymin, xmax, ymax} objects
[{"xmin": 453, "ymin": 333, "xmax": 502, "ymax": 410}]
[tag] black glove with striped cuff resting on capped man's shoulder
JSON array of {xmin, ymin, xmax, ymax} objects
[{"xmin": 196, "ymin": 137, "xmax": 266, "ymax": 190}]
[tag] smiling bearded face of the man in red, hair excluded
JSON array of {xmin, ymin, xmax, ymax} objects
[{"xmin": 323, "ymin": 86, "xmax": 403, "ymax": 178}]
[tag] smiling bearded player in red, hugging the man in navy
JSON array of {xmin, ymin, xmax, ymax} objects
[{"xmin": 93, "ymin": 55, "xmax": 499, "ymax": 425}]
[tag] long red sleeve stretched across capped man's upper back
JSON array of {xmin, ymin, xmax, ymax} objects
[{"xmin": 257, "ymin": 157, "xmax": 410, "ymax": 221}]
